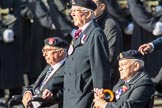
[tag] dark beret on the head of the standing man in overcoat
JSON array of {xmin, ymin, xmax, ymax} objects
[{"xmin": 71, "ymin": 0, "xmax": 97, "ymax": 11}]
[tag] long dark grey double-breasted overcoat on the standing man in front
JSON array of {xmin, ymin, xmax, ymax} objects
[{"xmin": 63, "ymin": 20, "xmax": 110, "ymax": 108}]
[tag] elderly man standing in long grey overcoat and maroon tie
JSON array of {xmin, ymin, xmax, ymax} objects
[{"xmin": 60, "ymin": 0, "xmax": 110, "ymax": 108}]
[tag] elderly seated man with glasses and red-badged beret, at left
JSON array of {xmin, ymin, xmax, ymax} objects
[{"xmin": 22, "ymin": 37, "xmax": 68, "ymax": 108}]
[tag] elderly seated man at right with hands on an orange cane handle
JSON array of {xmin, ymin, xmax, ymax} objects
[{"xmin": 94, "ymin": 50, "xmax": 154, "ymax": 108}]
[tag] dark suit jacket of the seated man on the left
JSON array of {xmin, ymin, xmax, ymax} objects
[{"xmin": 24, "ymin": 64, "xmax": 64, "ymax": 107}]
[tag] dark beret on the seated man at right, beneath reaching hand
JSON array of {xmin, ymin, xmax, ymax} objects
[{"xmin": 118, "ymin": 50, "xmax": 143, "ymax": 60}]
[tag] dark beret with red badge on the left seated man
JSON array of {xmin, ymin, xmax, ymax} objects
[{"xmin": 44, "ymin": 37, "xmax": 69, "ymax": 48}]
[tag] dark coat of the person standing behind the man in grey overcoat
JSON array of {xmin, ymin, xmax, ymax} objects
[{"xmin": 97, "ymin": 11, "xmax": 123, "ymax": 85}]
